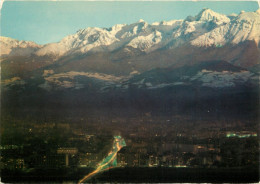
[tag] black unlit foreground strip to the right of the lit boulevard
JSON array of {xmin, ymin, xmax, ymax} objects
[{"xmin": 91, "ymin": 168, "xmax": 259, "ymax": 183}]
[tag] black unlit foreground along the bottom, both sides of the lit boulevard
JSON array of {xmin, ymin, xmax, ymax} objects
[{"xmin": 2, "ymin": 167, "xmax": 259, "ymax": 183}]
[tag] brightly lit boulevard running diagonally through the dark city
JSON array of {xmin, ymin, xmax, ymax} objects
[{"xmin": 78, "ymin": 136, "xmax": 126, "ymax": 184}]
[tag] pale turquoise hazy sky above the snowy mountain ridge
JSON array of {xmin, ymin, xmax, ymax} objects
[{"xmin": 1, "ymin": 1, "xmax": 258, "ymax": 44}]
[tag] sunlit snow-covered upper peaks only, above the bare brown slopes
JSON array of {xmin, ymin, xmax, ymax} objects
[{"xmin": 0, "ymin": 9, "xmax": 260, "ymax": 59}]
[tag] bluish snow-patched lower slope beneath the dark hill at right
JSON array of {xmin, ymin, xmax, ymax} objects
[{"xmin": 116, "ymin": 69, "xmax": 259, "ymax": 89}]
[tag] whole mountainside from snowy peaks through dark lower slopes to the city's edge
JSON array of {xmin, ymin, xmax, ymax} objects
[{"xmin": 0, "ymin": 9, "xmax": 260, "ymax": 118}]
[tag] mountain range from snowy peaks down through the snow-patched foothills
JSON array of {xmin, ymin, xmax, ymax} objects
[{"xmin": 0, "ymin": 9, "xmax": 260, "ymax": 92}]
